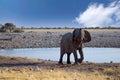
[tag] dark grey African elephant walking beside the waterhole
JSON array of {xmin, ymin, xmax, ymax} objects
[{"xmin": 58, "ymin": 29, "xmax": 91, "ymax": 64}]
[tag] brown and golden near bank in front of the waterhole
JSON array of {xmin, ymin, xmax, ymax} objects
[{"xmin": 0, "ymin": 56, "xmax": 120, "ymax": 80}]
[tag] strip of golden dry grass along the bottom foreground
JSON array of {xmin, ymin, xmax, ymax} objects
[{"xmin": 0, "ymin": 69, "xmax": 112, "ymax": 80}]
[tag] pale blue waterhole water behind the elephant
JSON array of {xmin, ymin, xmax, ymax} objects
[{"xmin": 0, "ymin": 48, "xmax": 120, "ymax": 62}]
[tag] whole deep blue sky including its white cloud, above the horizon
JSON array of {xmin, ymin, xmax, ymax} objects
[{"xmin": 0, "ymin": 0, "xmax": 120, "ymax": 27}]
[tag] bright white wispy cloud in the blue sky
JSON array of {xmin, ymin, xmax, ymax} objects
[{"xmin": 75, "ymin": 0, "xmax": 120, "ymax": 27}]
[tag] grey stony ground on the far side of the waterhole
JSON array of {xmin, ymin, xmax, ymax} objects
[{"xmin": 0, "ymin": 29, "xmax": 120, "ymax": 49}]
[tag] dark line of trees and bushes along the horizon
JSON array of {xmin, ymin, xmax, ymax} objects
[{"xmin": 0, "ymin": 23, "xmax": 120, "ymax": 32}]
